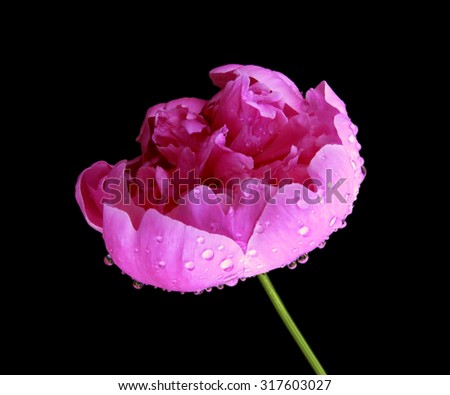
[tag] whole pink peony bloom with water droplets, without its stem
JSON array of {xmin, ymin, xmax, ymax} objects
[{"xmin": 76, "ymin": 65, "xmax": 364, "ymax": 292}]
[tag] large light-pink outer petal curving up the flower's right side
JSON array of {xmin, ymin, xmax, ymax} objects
[{"xmin": 245, "ymin": 145, "xmax": 362, "ymax": 276}]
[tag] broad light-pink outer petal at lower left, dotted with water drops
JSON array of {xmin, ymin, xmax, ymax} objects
[{"xmin": 103, "ymin": 206, "xmax": 244, "ymax": 292}]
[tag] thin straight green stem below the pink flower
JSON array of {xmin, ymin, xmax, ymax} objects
[{"xmin": 258, "ymin": 274, "xmax": 327, "ymax": 374}]
